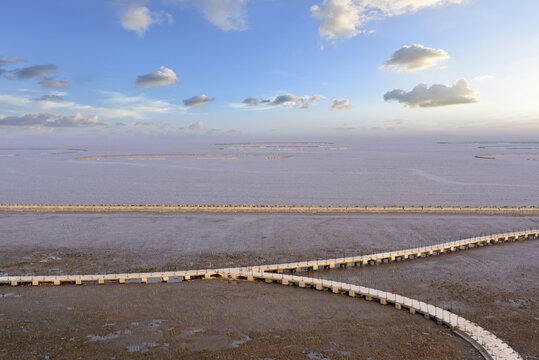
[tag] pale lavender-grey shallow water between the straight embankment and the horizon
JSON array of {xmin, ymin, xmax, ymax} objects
[{"xmin": 0, "ymin": 139, "xmax": 539, "ymax": 206}]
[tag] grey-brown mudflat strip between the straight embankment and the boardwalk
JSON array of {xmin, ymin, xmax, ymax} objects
[{"xmin": 0, "ymin": 213, "xmax": 539, "ymax": 275}]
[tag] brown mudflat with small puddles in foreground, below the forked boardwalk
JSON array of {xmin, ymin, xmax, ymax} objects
[{"xmin": 0, "ymin": 280, "xmax": 480, "ymax": 359}]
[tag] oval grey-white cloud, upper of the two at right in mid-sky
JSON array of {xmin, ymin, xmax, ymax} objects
[{"xmin": 380, "ymin": 44, "xmax": 449, "ymax": 71}]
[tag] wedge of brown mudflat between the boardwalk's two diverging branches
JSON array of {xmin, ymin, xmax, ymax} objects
[{"xmin": 306, "ymin": 240, "xmax": 539, "ymax": 359}]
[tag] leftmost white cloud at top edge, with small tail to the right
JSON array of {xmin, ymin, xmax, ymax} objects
[{"xmin": 119, "ymin": 0, "xmax": 173, "ymax": 37}]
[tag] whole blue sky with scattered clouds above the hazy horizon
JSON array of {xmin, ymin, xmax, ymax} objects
[{"xmin": 0, "ymin": 0, "xmax": 539, "ymax": 136}]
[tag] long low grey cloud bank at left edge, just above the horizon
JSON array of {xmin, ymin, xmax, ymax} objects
[{"xmin": 0, "ymin": 113, "xmax": 102, "ymax": 128}]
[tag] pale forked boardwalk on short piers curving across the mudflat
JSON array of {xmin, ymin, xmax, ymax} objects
[{"xmin": 0, "ymin": 229, "xmax": 539, "ymax": 359}]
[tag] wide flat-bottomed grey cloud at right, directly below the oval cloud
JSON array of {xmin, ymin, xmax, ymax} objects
[{"xmin": 384, "ymin": 80, "xmax": 478, "ymax": 108}]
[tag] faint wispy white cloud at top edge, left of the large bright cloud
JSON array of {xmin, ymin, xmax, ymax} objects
[{"xmin": 193, "ymin": 0, "xmax": 247, "ymax": 31}]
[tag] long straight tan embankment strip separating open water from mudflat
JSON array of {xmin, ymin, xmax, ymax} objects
[{"xmin": 0, "ymin": 204, "xmax": 539, "ymax": 215}]
